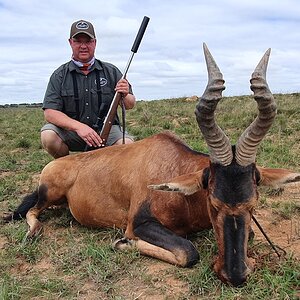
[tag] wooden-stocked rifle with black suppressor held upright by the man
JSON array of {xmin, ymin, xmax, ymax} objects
[{"xmin": 84, "ymin": 16, "xmax": 150, "ymax": 151}]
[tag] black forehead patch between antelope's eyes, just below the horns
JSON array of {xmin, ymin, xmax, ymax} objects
[{"xmin": 211, "ymin": 163, "xmax": 255, "ymax": 206}]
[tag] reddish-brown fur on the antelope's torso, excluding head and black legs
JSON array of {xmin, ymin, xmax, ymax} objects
[{"xmin": 33, "ymin": 133, "xmax": 210, "ymax": 238}]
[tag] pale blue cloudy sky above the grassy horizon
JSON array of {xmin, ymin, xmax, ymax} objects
[{"xmin": 0, "ymin": 0, "xmax": 300, "ymax": 104}]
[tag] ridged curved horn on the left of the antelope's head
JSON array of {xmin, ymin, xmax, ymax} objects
[{"xmin": 195, "ymin": 43, "xmax": 233, "ymax": 166}]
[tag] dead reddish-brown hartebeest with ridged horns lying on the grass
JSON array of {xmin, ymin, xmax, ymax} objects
[{"xmin": 5, "ymin": 45, "xmax": 300, "ymax": 286}]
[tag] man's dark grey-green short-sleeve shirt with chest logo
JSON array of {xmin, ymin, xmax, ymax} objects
[{"xmin": 43, "ymin": 59, "xmax": 132, "ymax": 126}]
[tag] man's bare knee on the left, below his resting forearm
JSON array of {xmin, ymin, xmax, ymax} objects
[{"xmin": 41, "ymin": 130, "xmax": 69, "ymax": 158}]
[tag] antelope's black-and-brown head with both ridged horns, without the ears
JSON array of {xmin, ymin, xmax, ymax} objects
[{"xmin": 195, "ymin": 44, "xmax": 276, "ymax": 286}]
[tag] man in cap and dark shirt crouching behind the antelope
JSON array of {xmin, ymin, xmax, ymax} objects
[{"xmin": 41, "ymin": 20, "xmax": 135, "ymax": 158}]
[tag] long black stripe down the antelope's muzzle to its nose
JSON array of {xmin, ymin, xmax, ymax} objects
[{"xmin": 224, "ymin": 216, "xmax": 246, "ymax": 286}]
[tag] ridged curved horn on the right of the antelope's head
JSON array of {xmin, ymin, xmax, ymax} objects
[{"xmin": 235, "ymin": 49, "xmax": 276, "ymax": 166}]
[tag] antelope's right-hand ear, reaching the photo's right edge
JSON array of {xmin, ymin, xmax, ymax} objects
[{"xmin": 256, "ymin": 167, "xmax": 300, "ymax": 188}]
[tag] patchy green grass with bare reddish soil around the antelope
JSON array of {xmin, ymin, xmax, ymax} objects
[{"xmin": 0, "ymin": 93, "xmax": 300, "ymax": 300}]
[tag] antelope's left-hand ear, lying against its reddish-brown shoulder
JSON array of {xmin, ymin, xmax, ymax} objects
[{"xmin": 148, "ymin": 170, "xmax": 203, "ymax": 195}]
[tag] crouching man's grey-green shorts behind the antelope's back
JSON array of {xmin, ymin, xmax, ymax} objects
[{"xmin": 41, "ymin": 123, "xmax": 134, "ymax": 151}]
